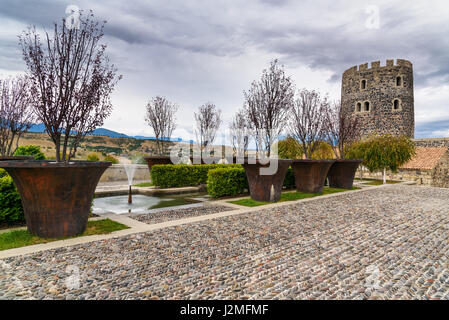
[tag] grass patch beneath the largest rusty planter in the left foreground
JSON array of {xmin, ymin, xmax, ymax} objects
[{"xmin": 0, "ymin": 219, "xmax": 129, "ymax": 251}]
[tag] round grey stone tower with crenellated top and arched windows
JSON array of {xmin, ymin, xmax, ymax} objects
[{"xmin": 341, "ymin": 59, "xmax": 415, "ymax": 138}]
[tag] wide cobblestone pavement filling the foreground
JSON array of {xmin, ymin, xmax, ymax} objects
[{"xmin": 0, "ymin": 185, "xmax": 449, "ymax": 299}]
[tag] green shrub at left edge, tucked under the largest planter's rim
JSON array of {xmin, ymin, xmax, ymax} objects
[{"xmin": 0, "ymin": 174, "xmax": 25, "ymax": 223}]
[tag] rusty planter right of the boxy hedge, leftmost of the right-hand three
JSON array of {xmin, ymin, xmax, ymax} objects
[{"xmin": 242, "ymin": 159, "xmax": 292, "ymax": 202}]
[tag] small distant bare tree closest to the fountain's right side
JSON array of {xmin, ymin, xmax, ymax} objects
[{"xmin": 145, "ymin": 96, "xmax": 178, "ymax": 154}]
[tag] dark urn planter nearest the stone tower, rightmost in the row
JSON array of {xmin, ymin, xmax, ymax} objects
[{"xmin": 327, "ymin": 159, "xmax": 362, "ymax": 189}]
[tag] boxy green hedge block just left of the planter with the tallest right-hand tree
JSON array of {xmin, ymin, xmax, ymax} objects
[{"xmin": 207, "ymin": 168, "xmax": 248, "ymax": 198}]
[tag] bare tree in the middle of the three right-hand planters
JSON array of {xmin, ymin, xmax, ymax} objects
[{"xmin": 289, "ymin": 89, "xmax": 329, "ymax": 159}]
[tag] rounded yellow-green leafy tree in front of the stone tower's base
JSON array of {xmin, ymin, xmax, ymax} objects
[{"xmin": 347, "ymin": 134, "xmax": 415, "ymax": 184}]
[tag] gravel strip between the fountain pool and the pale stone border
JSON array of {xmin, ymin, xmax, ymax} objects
[{"xmin": 129, "ymin": 205, "xmax": 235, "ymax": 224}]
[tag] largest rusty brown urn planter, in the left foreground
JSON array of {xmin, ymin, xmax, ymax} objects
[{"xmin": 0, "ymin": 160, "xmax": 111, "ymax": 238}]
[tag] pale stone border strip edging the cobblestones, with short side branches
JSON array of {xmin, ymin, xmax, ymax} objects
[{"xmin": 0, "ymin": 182, "xmax": 415, "ymax": 259}]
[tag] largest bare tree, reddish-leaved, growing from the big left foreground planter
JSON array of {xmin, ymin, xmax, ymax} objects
[{"xmin": 19, "ymin": 12, "xmax": 121, "ymax": 162}]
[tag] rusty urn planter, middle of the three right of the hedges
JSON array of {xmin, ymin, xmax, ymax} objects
[{"xmin": 292, "ymin": 160, "xmax": 335, "ymax": 193}]
